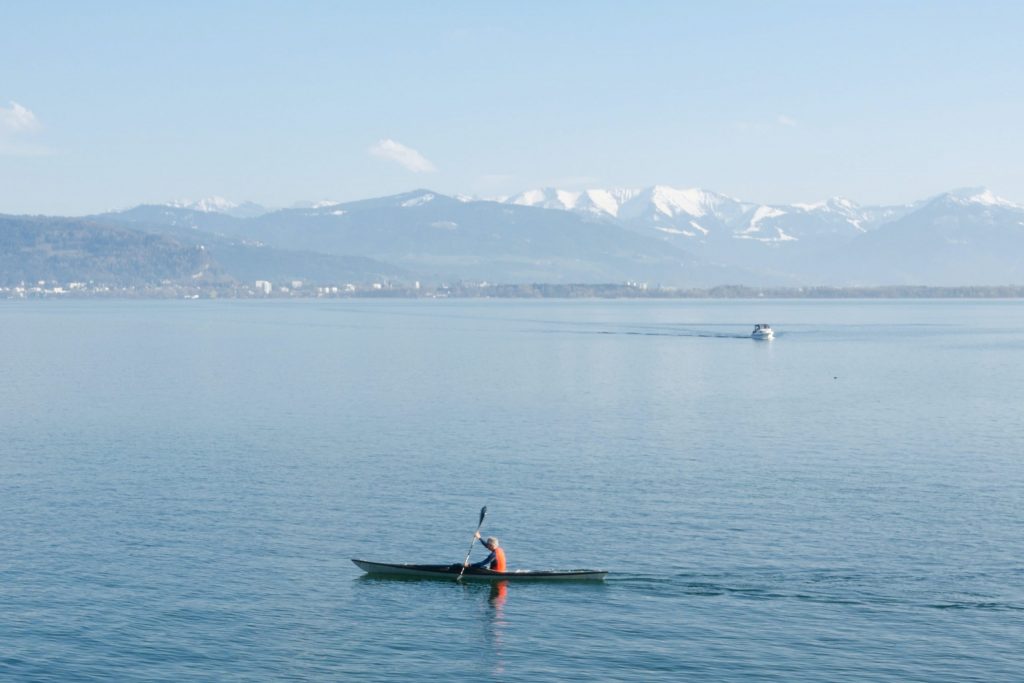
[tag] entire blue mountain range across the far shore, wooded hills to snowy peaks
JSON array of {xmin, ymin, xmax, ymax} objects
[{"xmin": 0, "ymin": 185, "xmax": 1024, "ymax": 287}]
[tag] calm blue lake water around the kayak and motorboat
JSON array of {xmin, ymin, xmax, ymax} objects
[{"xmin": 0, "ymin": 300, "xmax": 1024, "ymax": 682}]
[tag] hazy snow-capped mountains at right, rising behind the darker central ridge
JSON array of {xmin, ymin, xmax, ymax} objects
[{"xmin": 495, "ymin": 186, "xmax": 1024, "ymax": 285}]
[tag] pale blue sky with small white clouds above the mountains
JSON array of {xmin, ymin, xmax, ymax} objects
[{"xmin": 0, "ymin": 0, "xmax": 1024, "ymax": 215}]
